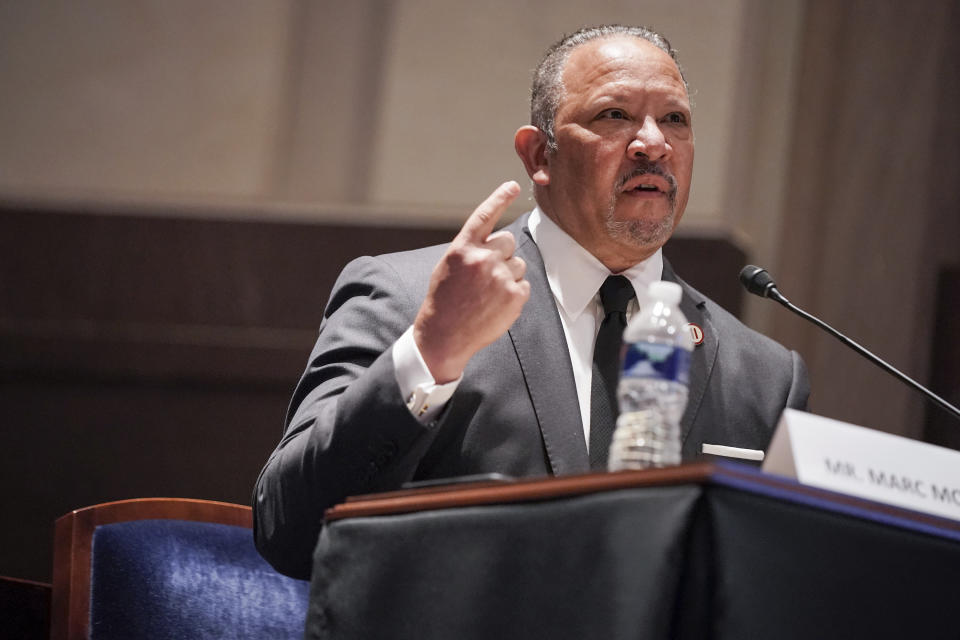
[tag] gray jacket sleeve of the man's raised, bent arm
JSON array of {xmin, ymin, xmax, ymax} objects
[{"xmin": 253, "ymin": 258, "xmax": 435, "ymax": 579}]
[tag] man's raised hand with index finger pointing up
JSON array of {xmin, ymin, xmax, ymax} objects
[{"xmin": 413, "ymin": 180, "xmax": 530, "ymax": 383}]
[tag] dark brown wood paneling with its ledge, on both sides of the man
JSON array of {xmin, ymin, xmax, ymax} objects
[{"xmin": 0, "ymin": 205, "xmax": 745, "ymax": 387}]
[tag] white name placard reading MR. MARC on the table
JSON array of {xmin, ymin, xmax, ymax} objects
[{"xmin": 763, "ymin": 409, "xmax": 960, "ymax": 520}]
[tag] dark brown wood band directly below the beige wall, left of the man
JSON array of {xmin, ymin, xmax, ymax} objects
[{"xmin": 0, "ymin": 208, "xmax": 453, "ymax": 328}]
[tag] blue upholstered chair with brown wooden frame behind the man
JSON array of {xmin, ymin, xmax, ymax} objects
[{"xmin": 51, "ymin": 498, "xmax": 309, "ymax": 640}]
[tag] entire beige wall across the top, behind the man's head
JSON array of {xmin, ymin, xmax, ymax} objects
[{"xmin": 0, "ymin": 0, "xmax": 800, "ymax": 230}]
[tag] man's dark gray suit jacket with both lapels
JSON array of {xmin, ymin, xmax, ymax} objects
[{"xmin": 253, "ymin": 216, "xmax": 809, "ymax": 578}]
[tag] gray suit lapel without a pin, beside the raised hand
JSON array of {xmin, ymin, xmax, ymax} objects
[{"xmin": 508, "ymin": 216, "xmax": 590, "ymax": 475}]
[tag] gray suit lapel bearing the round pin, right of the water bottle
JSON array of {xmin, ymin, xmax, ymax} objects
[{"xmin": 663, "ymin": 259, "xmax": 720, "ymax": 442}]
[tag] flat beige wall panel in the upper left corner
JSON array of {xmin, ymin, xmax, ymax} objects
[{"xmin": 0, "ymin": 0, "xmax": 291, "ymax": 199}]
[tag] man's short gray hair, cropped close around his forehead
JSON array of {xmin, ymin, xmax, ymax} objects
[{"xmin": 530, "ymin": 24, "xmax": 689, "ymax": 151}]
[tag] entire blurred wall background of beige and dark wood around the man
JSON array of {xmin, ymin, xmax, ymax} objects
[{"xmin": 0, "ymin": 0, "xmax": 960, "ymax": 580}]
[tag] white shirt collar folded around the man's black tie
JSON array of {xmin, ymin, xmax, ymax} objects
[{"xmin": 528, "ymin": 207, "xmax": 663, "ymax": 319}]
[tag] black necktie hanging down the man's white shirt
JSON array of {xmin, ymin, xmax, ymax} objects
[{"xmin": 590, "ymin": 276, "xmax": 635, "ymax": 470}]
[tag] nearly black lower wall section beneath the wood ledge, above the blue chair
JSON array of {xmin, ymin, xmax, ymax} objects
[{"xmin": 0, "ymin": 380, "xmax": 294, "ymax": 584}]
